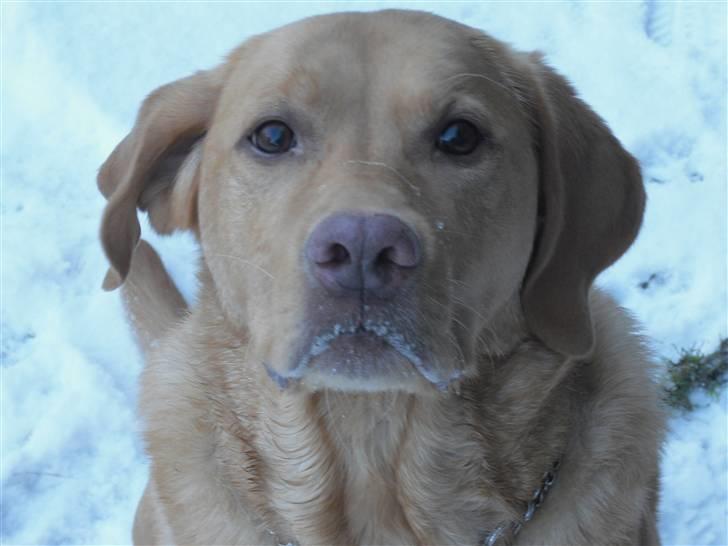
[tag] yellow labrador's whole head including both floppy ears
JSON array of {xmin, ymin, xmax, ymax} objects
[{"xmin": 99, "ymin": 11, "xmax": 644, "ymax": 390}]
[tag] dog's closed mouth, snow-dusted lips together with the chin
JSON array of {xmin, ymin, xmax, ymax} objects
[{"xmin": 265, "ymin": 320, "xmax": 461, "ymax": 391}]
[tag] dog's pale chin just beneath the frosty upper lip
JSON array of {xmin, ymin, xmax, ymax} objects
[{"xmin": 266, "ymin": 331, "xmax": 457, "ymax": 393}]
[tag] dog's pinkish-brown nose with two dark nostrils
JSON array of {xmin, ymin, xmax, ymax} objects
[{"xmin": 306, "ymin": 213, "xmax": 421, "ymax": 298}]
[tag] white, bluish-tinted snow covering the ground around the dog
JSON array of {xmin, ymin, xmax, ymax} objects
[{"xmin": 0, "ymin": 1, "xmax": 728, "ymax": 544}]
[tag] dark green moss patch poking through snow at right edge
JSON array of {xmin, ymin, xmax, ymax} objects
[{"xmin": 665, "ymin": 338, "xmax": 728, "ymax": 411}]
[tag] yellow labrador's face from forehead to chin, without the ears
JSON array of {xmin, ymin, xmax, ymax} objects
[{"xmin": 199, "ymin": 16, "xmax": 537, "ymax": 388}]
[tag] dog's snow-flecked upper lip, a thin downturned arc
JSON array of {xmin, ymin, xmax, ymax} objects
[{"xmin": 263, "ymin": 320, "xmax": 462, "ymax": 391}]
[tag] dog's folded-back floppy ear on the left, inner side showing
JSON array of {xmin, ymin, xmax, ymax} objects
[{"xmin": 98, "ymin": 69, "xmax": 223, "ymax": 288}]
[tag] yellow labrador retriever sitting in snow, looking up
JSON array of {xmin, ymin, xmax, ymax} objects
[{"xmin": 99, "ymin": 11, "xmax": 663, "ymax": 545}]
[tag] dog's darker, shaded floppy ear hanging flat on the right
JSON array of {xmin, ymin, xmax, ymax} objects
[{"xmin": 522, "ymin": 54, "xmax": 645, "ymax": 357}]
